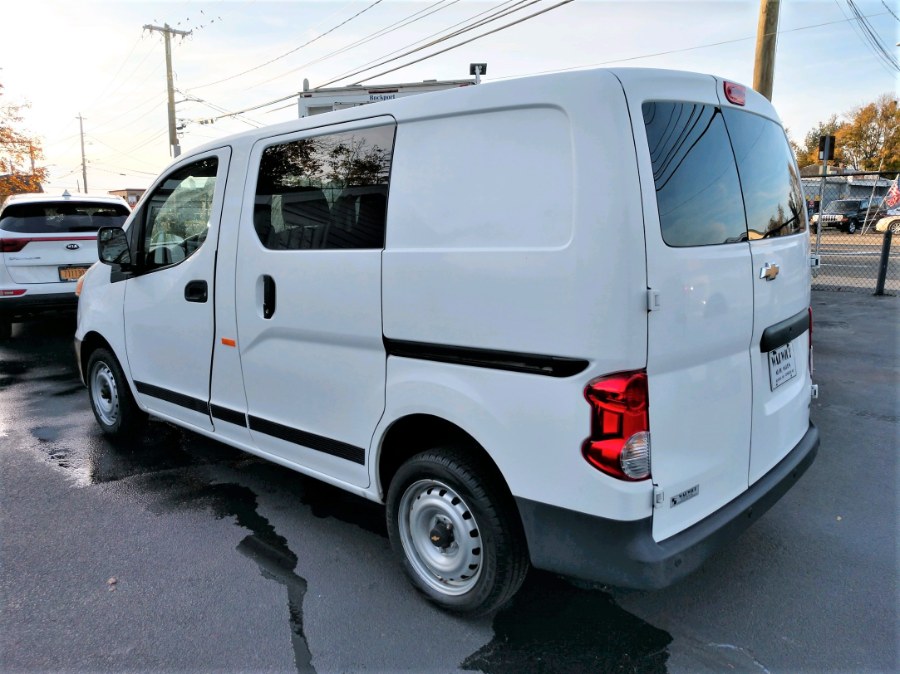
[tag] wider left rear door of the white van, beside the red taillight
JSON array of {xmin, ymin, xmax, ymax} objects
[{"xmin": 617, "ymin": 71, "xmax": 753, "ymax": 540}]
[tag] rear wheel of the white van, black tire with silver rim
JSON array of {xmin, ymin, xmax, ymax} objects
[{"xmin": 387, "ymin": 448, "xmax": 529, "ymax": 616}]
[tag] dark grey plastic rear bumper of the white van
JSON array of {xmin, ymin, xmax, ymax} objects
[{"xmin": 516, "ymin": 424, "xmax": 819, "ymax": 590}]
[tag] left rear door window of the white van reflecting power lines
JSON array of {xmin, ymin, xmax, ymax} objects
[{"xmin": 642, "ymin": 101, "xmax": 747, "ymax": 247}]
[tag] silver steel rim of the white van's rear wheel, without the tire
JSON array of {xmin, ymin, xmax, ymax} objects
[{"xmin": 399, "ymin": 480, "xmax": 483, "ymax": 596}]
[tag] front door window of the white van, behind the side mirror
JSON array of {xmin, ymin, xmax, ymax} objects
[{"xmin": 141, "ymin": 157, "xmax": 219, "ymax": 270}]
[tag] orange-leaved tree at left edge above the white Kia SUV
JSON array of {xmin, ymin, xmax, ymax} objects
[{"xmin": 0, "ymin": 84, "xmax": 47, "ymax": 199}]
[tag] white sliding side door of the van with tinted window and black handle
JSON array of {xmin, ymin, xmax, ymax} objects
[{"xmin": 235, "ymin": 117, "xmax": 395, "ymax": 487}]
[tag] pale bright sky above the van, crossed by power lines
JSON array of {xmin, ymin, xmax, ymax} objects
[{"xmin": 0, "ymin": 0, "xmax": 900, "ymax": 192}]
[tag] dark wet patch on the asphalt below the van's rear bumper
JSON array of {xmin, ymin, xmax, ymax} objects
[{"xmin": 460, "ymin": 571, "xmax": 672, "ymax": 674}]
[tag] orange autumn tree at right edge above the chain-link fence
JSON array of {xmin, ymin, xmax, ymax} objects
[{"xmin": 837, "ymin": 94, "xmax": 900, "ymax": 171}]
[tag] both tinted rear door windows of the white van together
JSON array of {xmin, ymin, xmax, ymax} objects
[{"xmin": 642, "ymin": 101, "xmax": 806, "ymax": 247}]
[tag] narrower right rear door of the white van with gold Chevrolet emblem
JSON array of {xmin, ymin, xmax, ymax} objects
[{"xmin": 717, "ymin": 81, "xmax": 811, "ymax": 484}]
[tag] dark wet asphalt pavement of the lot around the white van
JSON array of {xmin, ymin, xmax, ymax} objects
[{"xmin": 0, "ymin": 293, "xmax": 898, "ymax": 674}]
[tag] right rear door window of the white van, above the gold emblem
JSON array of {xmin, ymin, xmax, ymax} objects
[{"xmin": 723, "ymin": 109, "xmax": 806, "ymax": 240}]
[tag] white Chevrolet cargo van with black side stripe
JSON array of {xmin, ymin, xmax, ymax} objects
[{"xmin": 76, "ymin": 70, "xmax": 818, "ymax": 613}]
